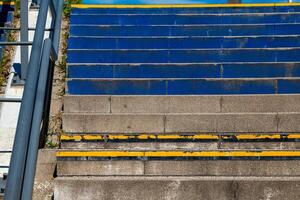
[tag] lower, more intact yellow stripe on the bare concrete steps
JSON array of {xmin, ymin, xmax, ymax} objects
[{"xmin": 56, "ymin": 151, "xmax": 300, "ymax": 157}]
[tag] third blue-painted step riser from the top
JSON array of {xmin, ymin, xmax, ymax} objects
[{"xmin": 70, "ymin": 24, "xmax": 300, "ymax": 37}]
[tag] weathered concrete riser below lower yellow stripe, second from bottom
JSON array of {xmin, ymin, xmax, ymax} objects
[{"xmin": 57, "ymin": 160, "xmax": 300, "ymax": 177}]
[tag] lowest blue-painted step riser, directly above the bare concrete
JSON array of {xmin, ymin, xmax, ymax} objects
[{"xmin": 67, "ymin": 79, "xmax": 300, "ymax": 95}]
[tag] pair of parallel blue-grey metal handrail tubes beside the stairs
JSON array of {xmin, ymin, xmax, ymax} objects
[{"xmin": 5, "ymin": 0, "xmax": 64, "ymax": 200}]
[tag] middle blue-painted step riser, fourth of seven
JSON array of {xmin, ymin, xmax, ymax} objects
[{"xmin": 68, "ymin": 36, "xmax": 300, "ymax": 49}]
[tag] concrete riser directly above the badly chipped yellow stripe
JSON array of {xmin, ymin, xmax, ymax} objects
[{"xmin": 63, "ymin": 113, "xmax": 300, "ymax": 133}]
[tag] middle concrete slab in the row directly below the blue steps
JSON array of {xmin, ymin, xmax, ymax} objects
[{"xmin": 111, "ymin": 96, "xmax": 221, "ymax": 113}]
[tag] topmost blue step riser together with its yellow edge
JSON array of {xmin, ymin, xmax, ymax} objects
[{"xmin": 72, "ymin": 5, "xmax": 300, "ymax": 15}]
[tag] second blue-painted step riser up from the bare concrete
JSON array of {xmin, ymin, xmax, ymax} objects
[{"xmin": 68, "ymin": 63, "xmax": 300, "ymax": 78}]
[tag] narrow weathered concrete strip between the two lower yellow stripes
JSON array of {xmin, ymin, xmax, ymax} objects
[{"xmin": 61, "ymin": 141, "xmax": 300, "ymax": 151}]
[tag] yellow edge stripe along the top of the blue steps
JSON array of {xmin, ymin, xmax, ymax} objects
[{"xmin": 71, "ymin": 3, "xmax": 300, "ymax": 8}]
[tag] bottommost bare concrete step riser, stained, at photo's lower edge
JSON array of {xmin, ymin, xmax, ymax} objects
[{"xmin": 54, "ymin": 176, "xmax": 300, "ymax": 200}]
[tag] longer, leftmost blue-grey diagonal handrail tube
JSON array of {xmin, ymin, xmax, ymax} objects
[{"xmin": 5, "ymin": 0, "xmax": 49, "ymax": 200}]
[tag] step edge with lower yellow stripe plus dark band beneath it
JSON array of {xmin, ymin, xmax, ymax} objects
[{"xmin": 56, "ymin": 149, "xmax": 300, "ymax": 161}]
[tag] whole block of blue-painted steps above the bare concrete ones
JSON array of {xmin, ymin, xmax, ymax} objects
[{"xmin": 67, "ymin": 6, "xmax": 300, "ymax": 95}]
